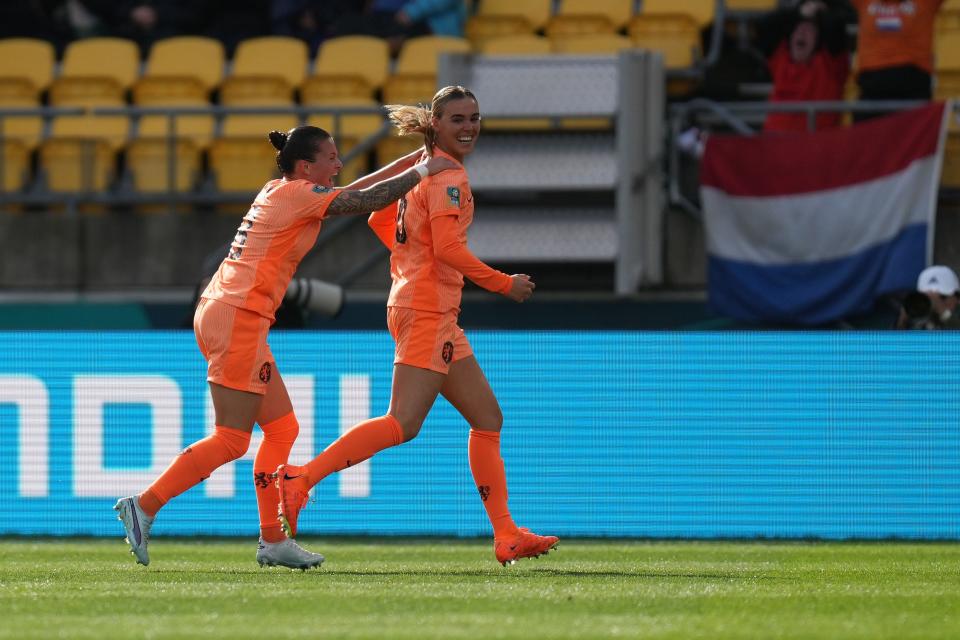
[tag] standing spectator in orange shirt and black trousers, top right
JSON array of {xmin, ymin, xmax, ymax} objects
[{"xmin": 851, "ymin": 0, "xmax": 943, "ymax": 121}]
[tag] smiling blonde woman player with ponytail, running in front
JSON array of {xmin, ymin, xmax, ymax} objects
[{"xmin": 277, "ymin": 87, "xmax": 558, "ymax": 565}]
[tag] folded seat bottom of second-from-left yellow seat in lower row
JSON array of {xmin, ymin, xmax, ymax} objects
[{"xmin": 40, "ymin": 138, "xmax": 115, "ymax": 192}]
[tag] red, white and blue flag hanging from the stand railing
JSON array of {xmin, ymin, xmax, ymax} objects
[{"xmin": 700, "ymin": 102, "xmax": 951, "ymax": 326}]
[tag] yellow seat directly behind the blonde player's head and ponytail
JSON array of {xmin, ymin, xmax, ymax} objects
[{"xmin": 383, "ymin": 36, "xmax": 470, "ymax": 104}]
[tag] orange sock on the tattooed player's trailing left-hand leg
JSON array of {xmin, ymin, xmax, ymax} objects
[{"xmin": 140, "ymin": 426, "xmax": 250, "ymax": 516}]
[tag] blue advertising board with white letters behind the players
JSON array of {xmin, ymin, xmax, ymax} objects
[{"xmin": 0, "ymin": 331, "xmax": 960, "ymax": 539}]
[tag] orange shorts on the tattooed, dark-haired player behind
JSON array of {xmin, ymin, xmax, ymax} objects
[{"xmin": 193, "ymin": 298, "xmax": 276, "ymax": 395}]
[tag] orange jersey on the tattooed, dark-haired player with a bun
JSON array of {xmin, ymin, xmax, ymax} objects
[{"xmin": 202, "ymin": 179, "xmax": 340, "ymax": 320}]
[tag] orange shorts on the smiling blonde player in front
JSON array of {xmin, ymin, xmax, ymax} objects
[{"xmin": 387, "ymin": 307, "xmax": 473, "ymax": 373}]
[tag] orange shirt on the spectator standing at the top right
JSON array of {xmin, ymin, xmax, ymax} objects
[{"xmin": 853, "ymin": 0, "xmax": 943, "ymax": 73}]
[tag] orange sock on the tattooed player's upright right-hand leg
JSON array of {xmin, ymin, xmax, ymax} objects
[{"xmin": 253, "ymin": 411, "xmax": 300, "ymax": 542}]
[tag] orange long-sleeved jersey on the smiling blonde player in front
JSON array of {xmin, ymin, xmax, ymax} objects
[{"xmin": 371, "ymin": 149, "xmax": 512, "ymax": 313}]
